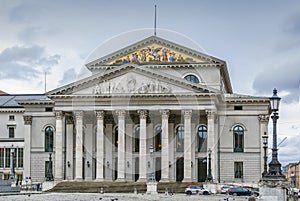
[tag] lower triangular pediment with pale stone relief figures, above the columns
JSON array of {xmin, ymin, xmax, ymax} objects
[{"xmin": 47, "ymin": 64, "xmax": 215, "ymax": 96}]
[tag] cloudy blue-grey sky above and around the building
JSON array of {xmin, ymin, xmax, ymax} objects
[{"xmin": 0, "ymin": 0, "xmax": 300, "ymax": 164}]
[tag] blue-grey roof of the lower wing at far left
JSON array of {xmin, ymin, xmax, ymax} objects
[{"xmin": 0, "ymin": 94, "xmax": 50, "ymax": 108}]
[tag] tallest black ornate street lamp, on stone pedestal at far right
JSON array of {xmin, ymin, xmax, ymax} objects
[{"xmin": 265, "ymin": 89, "xmax": 284, "ymax": 178}]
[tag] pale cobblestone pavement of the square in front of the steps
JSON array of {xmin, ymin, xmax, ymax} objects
[{"xmin": 0, "ymin": 193, "xmax": 258, "ymax": 201}]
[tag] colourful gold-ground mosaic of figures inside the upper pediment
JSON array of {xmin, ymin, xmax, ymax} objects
[{"xmin": 109, "ymin": 44, "xmax": 203, "ymax": 65}]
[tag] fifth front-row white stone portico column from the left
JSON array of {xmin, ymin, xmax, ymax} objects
[{"xmin": 138, "ymin": 110, "xmax": 148, "ymax": 182}]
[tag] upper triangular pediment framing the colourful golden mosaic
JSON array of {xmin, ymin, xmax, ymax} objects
[{"xmin": 86, "ymin": 36, "xmax": 223, "ymax": 69}]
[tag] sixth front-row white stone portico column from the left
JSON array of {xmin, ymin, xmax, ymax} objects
[{"xmin": 161, "ymin": 110, "xmax": 170, "ymax": 182}]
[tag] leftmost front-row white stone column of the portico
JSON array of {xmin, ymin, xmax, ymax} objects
[{"xmin": 54, "ymin": 111, "xmax": 63, "ymax": 181}]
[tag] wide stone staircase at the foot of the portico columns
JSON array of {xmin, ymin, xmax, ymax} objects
[{"xmin": 47, "ymin": 181, "xmax": 202, "ymax": 193}]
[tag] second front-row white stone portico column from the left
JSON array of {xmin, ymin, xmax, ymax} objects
[{"xmin": 75, "ymin": 111, "xmax": 83, "ymax": 180}]
